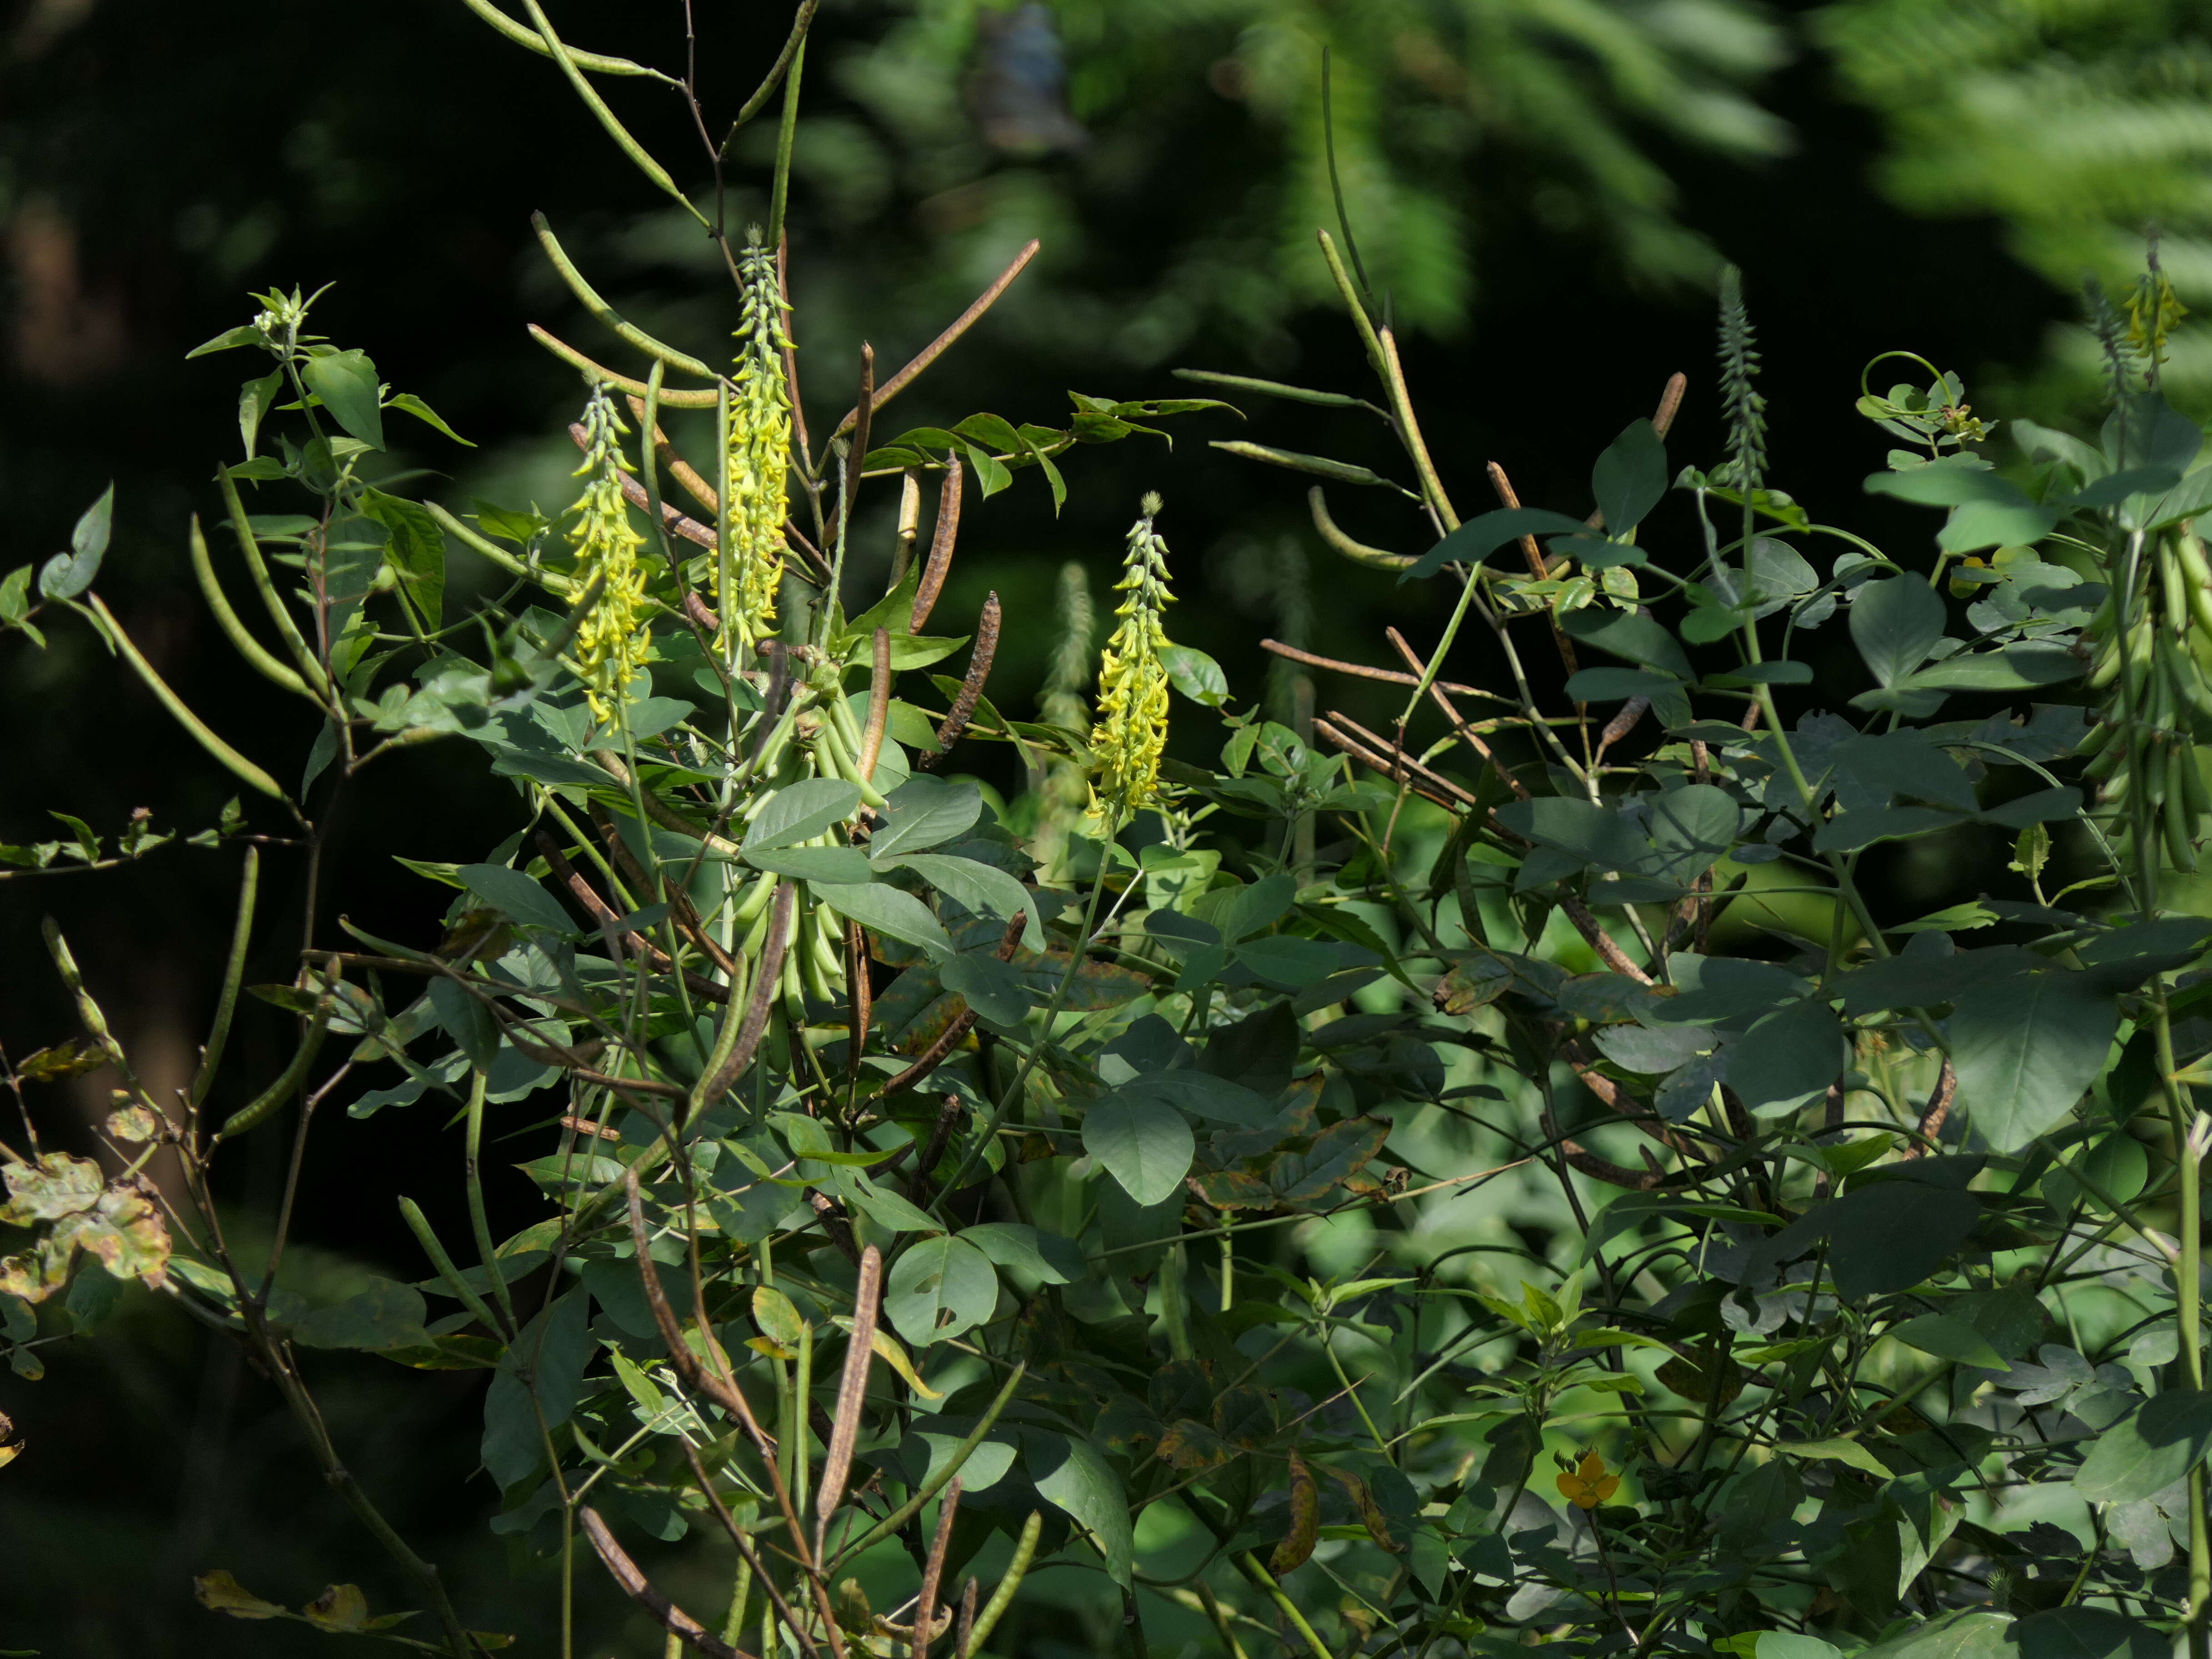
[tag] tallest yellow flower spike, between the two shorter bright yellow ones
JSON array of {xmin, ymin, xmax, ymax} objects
[{"xmin": 721, "ymin": 232, "xmax": 796, "ymax": 655}]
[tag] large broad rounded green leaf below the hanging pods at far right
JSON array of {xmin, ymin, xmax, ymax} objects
[{"xmin": 1949, "ymin": 969, "xmax": 2119, "ymax": 1152}]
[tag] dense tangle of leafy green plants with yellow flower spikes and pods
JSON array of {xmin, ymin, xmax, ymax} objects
[{"xmin": 0, "ymin": 0, "xmax": 2212, "ymax": 1659}]
